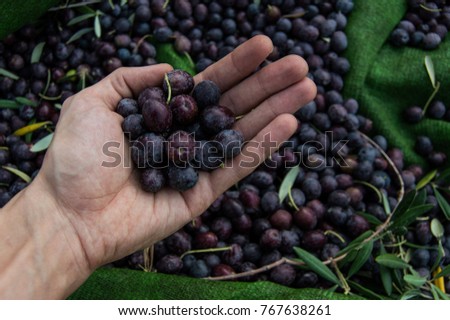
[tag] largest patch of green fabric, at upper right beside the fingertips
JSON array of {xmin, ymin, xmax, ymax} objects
[{"xmin": 344, "ymin": 0, "xmax": 450, "ymax": 164}]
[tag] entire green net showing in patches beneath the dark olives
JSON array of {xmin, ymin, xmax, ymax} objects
[{"xmin": 0, "ymin": 0, "xmax": 450, "ymax": 299}]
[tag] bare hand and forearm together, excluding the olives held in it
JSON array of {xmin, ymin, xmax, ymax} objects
[{"xmin": 0, "ymin": 36, "xmax": 316, "ymax": 299}]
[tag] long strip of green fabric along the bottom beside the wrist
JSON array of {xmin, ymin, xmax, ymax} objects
[{"xmin": 70, "ymin": 269, "xmax": 358, "ymax": 300}]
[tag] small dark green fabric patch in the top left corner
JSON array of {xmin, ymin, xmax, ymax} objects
[{"xmin": 0, "ymin": 0, "xmax": 59, "ymax": 39}]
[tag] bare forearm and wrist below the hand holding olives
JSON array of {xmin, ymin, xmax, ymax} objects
[{"xmin": 0, "ymin": 181, "xmax": 89, "ymax": 299}]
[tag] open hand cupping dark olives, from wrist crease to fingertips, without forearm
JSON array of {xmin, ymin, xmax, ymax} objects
[{"xmin": 37, "ymin": 36, "xmax": 316, "ymax": 270}]
